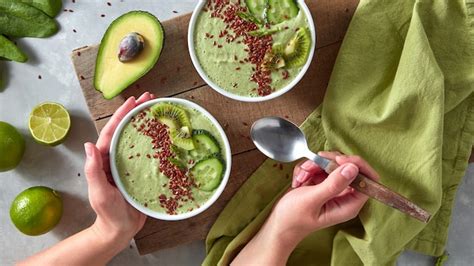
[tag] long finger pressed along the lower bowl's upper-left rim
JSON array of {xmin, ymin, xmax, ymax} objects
[{"xmin": 96, "ymin": 96, "xmax": 136, "ymax": 154}]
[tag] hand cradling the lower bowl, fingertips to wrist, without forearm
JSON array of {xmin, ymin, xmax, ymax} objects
[{"xmin": 84, "ymin": 92, "xmax": 154, "ymax": 251}]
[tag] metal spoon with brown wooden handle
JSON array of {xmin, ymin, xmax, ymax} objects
[{"xmin": 250, "ymin": 117, "xmax": 431, "ymax": 223}]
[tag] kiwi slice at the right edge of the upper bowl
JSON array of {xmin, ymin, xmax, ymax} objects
[{"xmin": 282, "ymin": 28, "xmax": 311, "ymax": 68}]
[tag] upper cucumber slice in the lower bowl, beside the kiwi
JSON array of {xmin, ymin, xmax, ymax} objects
[{"xmin": 190, "ymin": 129, "xmax": 221, "ymax": 160}]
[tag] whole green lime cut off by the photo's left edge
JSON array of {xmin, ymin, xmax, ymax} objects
[{"xmin": 0, "ymin": 121, "xmax": 25, "ymax": 172}]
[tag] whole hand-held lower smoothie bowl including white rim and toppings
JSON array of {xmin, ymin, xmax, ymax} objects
[{"xmin": 110, "ymin": 98, "xmax": 232, "ymax": 220}]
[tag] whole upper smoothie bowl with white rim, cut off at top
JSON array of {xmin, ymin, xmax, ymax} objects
[{"xmin": 188, "ymin": 0, "xmax": 316, "ymax": 102}]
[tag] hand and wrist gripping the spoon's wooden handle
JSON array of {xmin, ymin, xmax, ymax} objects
[{"xmin": 233, "ymin": 152, "xmax": 379, "ymax": 265}]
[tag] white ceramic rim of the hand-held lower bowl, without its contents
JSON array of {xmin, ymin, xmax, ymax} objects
[{"xmin": 110, "ymin": 98, "xmax": 232, "ymax": 221}]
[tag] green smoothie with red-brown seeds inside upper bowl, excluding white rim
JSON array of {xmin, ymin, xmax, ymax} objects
[{"xmin": 194, "ymin": 0, "xmax": 311, "ymax": 97}]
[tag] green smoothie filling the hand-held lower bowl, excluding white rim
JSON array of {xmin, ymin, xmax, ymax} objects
[{"xmin": 115, "ymin": 103, "xmax": 225, "ymax": 214}]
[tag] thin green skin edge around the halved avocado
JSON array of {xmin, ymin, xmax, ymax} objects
[{"xmin": 93, "ymin": 10, "xmax": 166, "ymax": 100}]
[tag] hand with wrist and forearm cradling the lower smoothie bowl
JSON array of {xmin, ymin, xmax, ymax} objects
[{"xmin": 18, "ymin": 92, "xmax": 154, "ymax": 266}]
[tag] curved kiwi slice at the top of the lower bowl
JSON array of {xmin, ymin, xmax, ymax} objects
[{"xmin": 151, "ymin": 103, "xmax": 195, "ymax": 150}]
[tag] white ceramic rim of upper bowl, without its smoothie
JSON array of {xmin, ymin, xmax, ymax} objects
[{"xmin": 188, "ymin": 0, "xmax": 316, "ymax": 102}]
